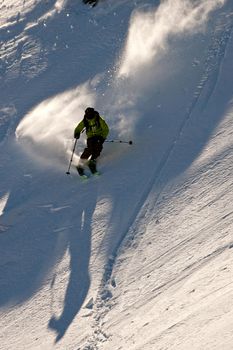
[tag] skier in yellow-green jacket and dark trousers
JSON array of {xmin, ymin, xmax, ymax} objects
[{"xmin": 74, "ymin": 107, "xmax": 109, "ymax": 176}]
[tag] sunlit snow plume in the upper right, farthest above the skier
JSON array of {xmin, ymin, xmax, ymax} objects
[{"xmin": 119, "ymin": 0, "xmax": 225, "ymax": 76}]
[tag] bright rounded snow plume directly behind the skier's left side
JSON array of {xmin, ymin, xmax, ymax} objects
[{"xmin": 16, "ymin": 83, "xmax": 95, "ymax": 168}]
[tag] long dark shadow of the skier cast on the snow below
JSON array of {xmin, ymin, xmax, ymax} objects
[{"xmin": 48, "ymin": 186, "xmax": 97, "ymax": 343}]
